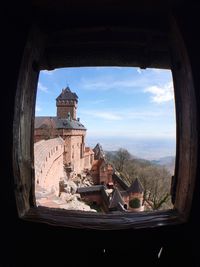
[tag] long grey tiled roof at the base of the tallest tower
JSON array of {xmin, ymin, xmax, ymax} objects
[{"xmin": 35, "ymin": 117, "xmax": 86, "ymax": 130}]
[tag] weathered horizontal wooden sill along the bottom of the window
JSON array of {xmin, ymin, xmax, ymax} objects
[{"xmin": 23, "ymin": 207, "xmax": 182, "ymax": 230}]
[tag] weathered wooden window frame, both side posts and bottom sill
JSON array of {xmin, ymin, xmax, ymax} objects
[{"xmin": 13, "ymin": 18, "xmax": 198, "ymax": 230}]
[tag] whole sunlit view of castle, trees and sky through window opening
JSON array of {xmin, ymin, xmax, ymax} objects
[{"xmin": 34, "ymin": 67, "xmax": 176, "ymax": 213}]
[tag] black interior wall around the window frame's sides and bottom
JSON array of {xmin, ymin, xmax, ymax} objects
[{"xmin": 0, "ymin": 1, "xmax": 200, "ymax": 266}]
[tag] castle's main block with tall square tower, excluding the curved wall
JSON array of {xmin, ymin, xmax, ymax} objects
[{"xmin": 34, "ymin": 87, "xmax": 94, "ymax": 173}]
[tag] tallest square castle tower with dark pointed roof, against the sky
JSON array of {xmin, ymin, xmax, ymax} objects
[{"xmin": 56, "ymin": 87, "xmax": 78, "ymax": 120}]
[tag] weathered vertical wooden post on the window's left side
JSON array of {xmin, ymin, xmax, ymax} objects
[{"xmin": 13, "ymin": 28, "xmax": 44, "ymax": 217}]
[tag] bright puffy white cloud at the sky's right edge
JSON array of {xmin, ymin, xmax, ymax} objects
[{"xmin": 144, "ymin": 82, "xmax": 174, "ymax": 103}]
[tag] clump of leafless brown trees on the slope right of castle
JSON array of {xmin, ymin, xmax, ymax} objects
[{"xmin": 110, "ymin": 148, "xmax": 172, "ymax": 210}]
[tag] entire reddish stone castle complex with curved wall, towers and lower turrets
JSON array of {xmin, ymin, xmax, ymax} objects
[{"xmin": 34, "ymin": 87, "xmax": 144, "ymax": 212}]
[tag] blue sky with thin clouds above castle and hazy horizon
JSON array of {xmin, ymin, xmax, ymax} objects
[{"xmin": 36, "ymin": 67, "xmax": 176, "ymax": 159}]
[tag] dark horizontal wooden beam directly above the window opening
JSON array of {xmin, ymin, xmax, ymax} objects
[{"xmin": 40, "ymin": 45, "xmax": 171, "ymax": 70}]
